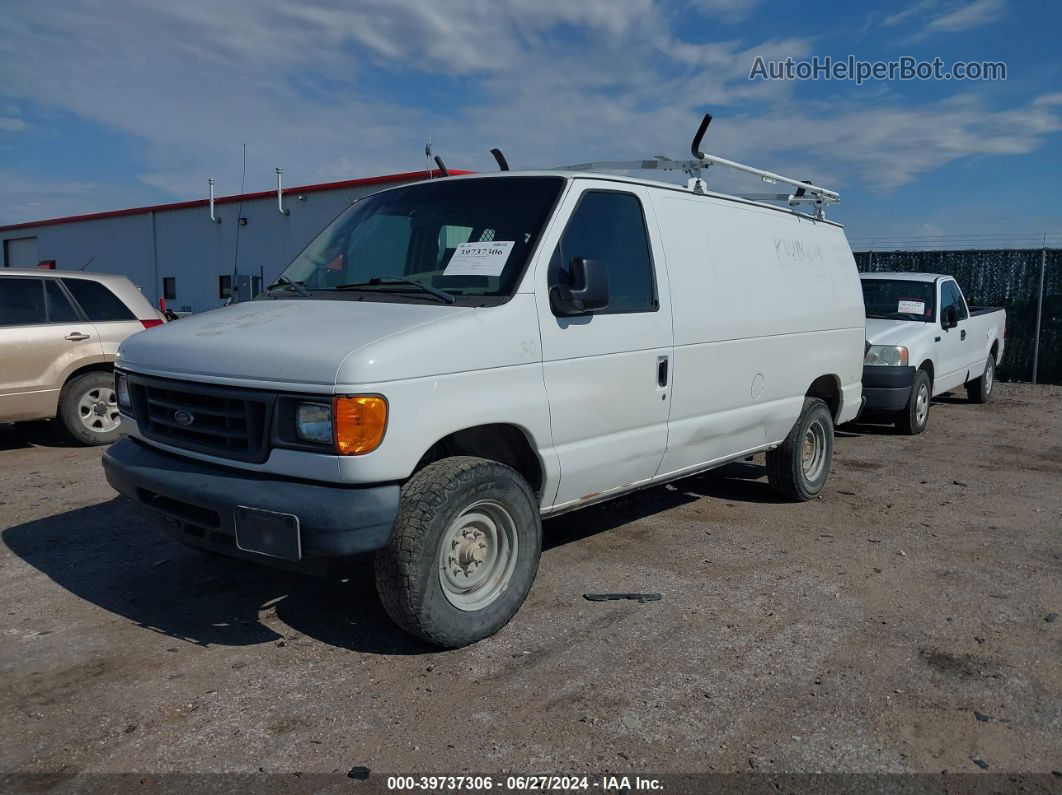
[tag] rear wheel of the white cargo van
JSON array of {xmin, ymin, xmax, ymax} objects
[{"xmin": 767, "ymin": 398, "xmax": 834, "ymax": 502}]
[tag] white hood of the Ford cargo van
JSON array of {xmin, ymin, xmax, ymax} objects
[{"xmin": 118, "ymin": 298, "xmax": 473, "ymax": 386}]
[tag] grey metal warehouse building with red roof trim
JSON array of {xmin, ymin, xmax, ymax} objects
[{"xmin": 0, "ymin": 171, "xmax": 452, "ymax": 312}]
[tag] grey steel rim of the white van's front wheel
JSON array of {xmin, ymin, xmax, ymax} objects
[{"xmin": 438, "ymin": 500, "xmax": 519, "ymax": 612}]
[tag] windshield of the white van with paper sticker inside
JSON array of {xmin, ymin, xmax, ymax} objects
[{"xmin": 261, "ymin": 176, "xmax": 564, "ymax": 306}]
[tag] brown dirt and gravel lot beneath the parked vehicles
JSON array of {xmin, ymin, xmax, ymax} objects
[{"xmin": 0, "ymin": 384, "xmax": 1062, "ymax": 781}]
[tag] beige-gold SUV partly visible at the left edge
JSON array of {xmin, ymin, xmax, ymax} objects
[{"xmin": 0, "ymin": 269, "xmax": 165, "ymax": 445}]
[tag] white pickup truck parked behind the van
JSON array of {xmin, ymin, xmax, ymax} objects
[{"xmin": 860, "ymin": 273, "xmax": 1007, "ymax": 434}]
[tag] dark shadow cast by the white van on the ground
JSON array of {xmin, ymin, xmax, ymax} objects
[{"xmin": 2, "ymin": 464, "xmax": 776, "ymax": 655}]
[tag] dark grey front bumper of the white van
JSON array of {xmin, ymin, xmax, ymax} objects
[{"xmin": 103, "ymin": 437, "xmax": 399, "ymax": 573}]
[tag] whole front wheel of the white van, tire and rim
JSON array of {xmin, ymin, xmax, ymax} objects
[{"xmin": 375, "ymin": 456, "xmax": 542, "ymax": 649}]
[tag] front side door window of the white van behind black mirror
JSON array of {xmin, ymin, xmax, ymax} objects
[{"xmin": 549, "ymin": 191, "xmax": 657, "ymax": 312}]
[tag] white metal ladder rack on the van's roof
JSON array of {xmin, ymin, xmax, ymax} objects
[{"xmin": 558, "ymin": 114, "xmax": 841, "ymax": 220}]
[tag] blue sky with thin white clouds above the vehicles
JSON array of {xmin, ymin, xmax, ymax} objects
[{"xmin": 0, "ymin": 0, "xmax": 1062, "ymax": 241}]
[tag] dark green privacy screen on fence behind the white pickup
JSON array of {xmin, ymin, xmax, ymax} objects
[{"xmin": 855, "ymin": 248, "xmax": 1062, "ymax": 384}]
